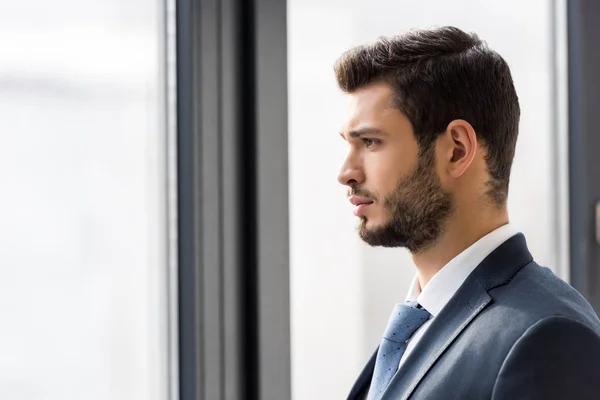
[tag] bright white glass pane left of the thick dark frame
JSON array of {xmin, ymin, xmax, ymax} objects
[{"xmin": 0, "ymin": 0, "xmax": 168, "ymax": 400}]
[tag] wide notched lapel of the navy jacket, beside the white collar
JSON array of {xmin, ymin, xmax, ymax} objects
[{"xmin": 382, "ymin": 234, "xmax": 533, "ymax": 400}]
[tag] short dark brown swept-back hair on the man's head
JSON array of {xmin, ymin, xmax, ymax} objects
[{"xmin": 335, "ymin": 27, "xmax": 520, "ymax": 206}]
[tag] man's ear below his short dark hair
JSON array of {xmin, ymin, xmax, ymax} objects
[{"xmin": 446, "ymin": 119, "xmax": 477, "ymax": 178}]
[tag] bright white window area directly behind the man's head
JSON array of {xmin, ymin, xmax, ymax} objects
[{"xmin": 288, "ymin": 0, "xmax": 564, "ymax": 400}]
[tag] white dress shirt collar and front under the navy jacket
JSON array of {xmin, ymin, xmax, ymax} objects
[{"xmin": 400, "ymin": 224, "xmax": 517, "ymax": 366}]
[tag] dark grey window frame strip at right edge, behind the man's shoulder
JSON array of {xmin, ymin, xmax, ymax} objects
[{"xmin": 567, "ymin": 0, "xmax": 600, "ymax": 312}]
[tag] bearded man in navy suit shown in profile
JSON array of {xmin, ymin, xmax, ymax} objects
[{"xmin": 335, "ymin": 27, "xmax": 600, "ymax": 400}]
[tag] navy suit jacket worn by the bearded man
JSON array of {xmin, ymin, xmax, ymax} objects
[{"xmin": 348, "ymin": 234, "xmax": 600, "ymax": 400}]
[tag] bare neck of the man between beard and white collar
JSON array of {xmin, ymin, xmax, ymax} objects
[{"xmin": 412, "ymin": 208, "xmax": 508, "ymax": 289}]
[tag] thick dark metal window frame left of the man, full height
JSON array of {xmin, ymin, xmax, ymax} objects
[{"xmin": 176, "ymin": 0, "xmax": 291, "ymax": 400}]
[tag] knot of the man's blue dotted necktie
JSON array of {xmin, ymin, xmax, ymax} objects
[{"xmin": 383, "ymin": 301, "xmax": 431, "ymax": 343}]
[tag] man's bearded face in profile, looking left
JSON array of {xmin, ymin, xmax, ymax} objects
[{"xmin": 338, "ymin": 84, "xmax": 453, "ymax": 253}]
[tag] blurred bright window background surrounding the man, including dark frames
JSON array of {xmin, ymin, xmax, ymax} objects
[{"xmin": 0, "ymin": 0, "xmax": 600, "ymax": 400}]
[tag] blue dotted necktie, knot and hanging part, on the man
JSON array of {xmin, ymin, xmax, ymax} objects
[{"xmin": 368, "ymin": 301, "xmax": 431, "ymax": 400}]
